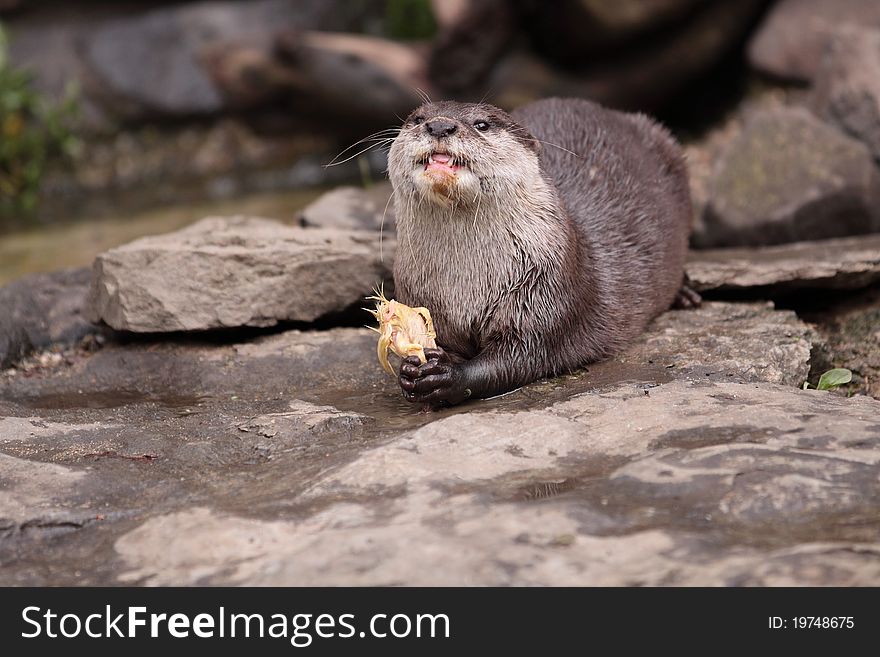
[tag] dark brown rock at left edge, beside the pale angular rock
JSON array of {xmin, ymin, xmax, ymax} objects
[{"xmin": 0, "ymin": 269, "xmax": 96, "ymax": 370}]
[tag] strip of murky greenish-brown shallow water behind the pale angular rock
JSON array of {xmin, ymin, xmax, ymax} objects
[{"xmin": 0, "ymin": 188, "xmax": 324, "ymax": 285}]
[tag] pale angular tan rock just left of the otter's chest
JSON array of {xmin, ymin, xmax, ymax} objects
[{"xmin": 89, "ymin": 217, "xmax": 390, "ymax": 332}]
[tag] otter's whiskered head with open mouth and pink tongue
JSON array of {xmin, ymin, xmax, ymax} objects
[{"xmin": 388, "ymin": 101, "xmax": 541, "ymax": 206}]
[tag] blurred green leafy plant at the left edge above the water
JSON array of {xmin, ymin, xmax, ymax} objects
[{"xmin": 0, "ymin": 26, "xmax": 77, "ymax": 220}]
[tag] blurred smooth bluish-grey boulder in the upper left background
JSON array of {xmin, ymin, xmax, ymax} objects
[{"xmin": 82, "ymin": 0, "xmax": 374, "ymax": 119}]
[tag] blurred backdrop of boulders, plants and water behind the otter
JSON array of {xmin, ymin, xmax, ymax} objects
[{"xmin": 0, "ymin": 0, "xmax": 880, "ymax": 284}]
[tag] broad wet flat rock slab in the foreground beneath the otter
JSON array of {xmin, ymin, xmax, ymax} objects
[{"xmin": 0, "ymin": 303, "xmax": 880, "ymax": 585}]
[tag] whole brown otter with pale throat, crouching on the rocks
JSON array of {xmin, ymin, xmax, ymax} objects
[{"xmin": 388, "ymin": 98, "xmax": 699, "ymax": 407}]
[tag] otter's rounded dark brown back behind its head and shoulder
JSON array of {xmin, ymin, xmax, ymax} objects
[{"xmin": 512, "ymin": 98, "xmax": 692, "ymax": 322}]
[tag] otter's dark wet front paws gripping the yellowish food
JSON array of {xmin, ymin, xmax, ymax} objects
[{"xmin": 398, "ymin": 349, "xmax": 471, "ymax": 406}]
